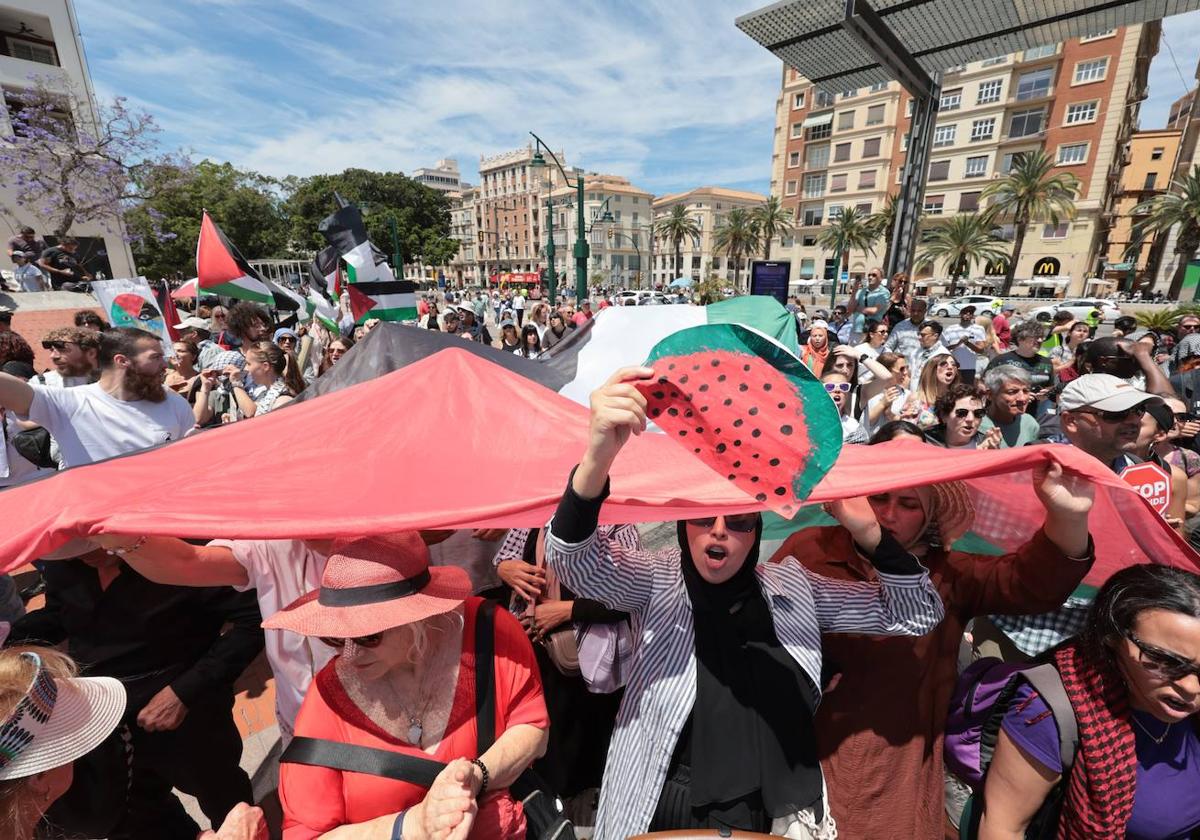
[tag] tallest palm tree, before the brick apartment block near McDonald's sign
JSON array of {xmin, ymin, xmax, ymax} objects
[{"xmin": 980, "ymin": 150, "xmax": 1080, "ymax": 298}]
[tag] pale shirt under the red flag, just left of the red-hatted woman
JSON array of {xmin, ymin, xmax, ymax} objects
[{"xmin": 209, "ymin": 540, "xmax": 337, "ymax": 740}]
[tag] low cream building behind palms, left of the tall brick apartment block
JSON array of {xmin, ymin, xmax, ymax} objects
[{"xmin": 652, "ymin": 187, "xmax": 778, "ymax": 286}]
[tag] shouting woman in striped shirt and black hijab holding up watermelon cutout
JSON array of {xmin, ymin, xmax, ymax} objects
[{"xmin": 546, "ymin": 367, "xmax": 942, "ymax": 840}]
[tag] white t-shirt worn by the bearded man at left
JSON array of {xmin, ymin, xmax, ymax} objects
[{"xmin": 26, "ymin": 383, "xmax": 196, "ymax": 468}]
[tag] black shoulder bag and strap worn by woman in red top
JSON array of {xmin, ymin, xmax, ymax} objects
[{"xmin": 280, "ymin": 601, "xmax": 575, "ymax": 840}]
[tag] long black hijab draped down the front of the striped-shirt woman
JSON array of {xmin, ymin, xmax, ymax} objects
[{"xmin": 678, "ymin": 517, "xmax": 823, "ymax": 828}]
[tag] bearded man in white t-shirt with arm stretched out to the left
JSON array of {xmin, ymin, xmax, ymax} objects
[{"xmin": 0, "ymin": 328, "xmax": 196, "ymax": 468}]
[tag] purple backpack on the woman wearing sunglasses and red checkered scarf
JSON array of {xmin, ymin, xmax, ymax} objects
[{"xmin": 942, "ymin": 656, "xmax": 1079, "ymax": 792}]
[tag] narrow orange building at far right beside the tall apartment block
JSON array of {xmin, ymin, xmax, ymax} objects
[{"xmin": 1088, "ymin": 130, "xmax": 1183, "ymax": 293}]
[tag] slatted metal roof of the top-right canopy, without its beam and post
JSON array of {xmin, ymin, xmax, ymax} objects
[{"xmin": 736, "ymin": 0, "xmax": 1200, "ymax": 91}]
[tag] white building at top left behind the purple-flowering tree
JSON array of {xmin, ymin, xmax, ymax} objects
[{"xmin": 0, "ymin": 0, "xmax": 137, "ymax": 277}]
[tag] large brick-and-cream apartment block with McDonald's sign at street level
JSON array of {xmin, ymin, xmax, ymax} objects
[{"xmin": 772, "ymin": 22, "xmax": 1160, "ymax": 294}]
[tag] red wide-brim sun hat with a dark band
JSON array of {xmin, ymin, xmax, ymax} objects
[{"xmin": 263, "ymin": 530, "xmax": 472, "ymax": 638}]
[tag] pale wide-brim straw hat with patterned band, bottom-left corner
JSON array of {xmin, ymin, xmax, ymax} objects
[{"xmin": 0, "ymin": 653, "xmax": 125, "ymax": 781}]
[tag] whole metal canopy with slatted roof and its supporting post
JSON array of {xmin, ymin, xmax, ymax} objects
[{"xmin": 736, "ymin": 0, "xmax": 1200, "ymax": 282}]
